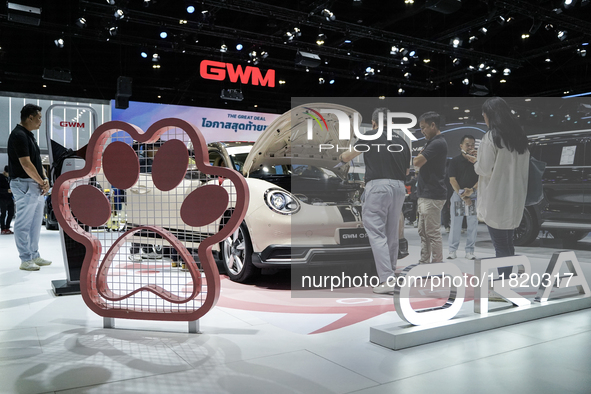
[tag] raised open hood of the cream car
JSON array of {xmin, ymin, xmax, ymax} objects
[{"xmin": 243, "ymin": 103, "xmax": 361, "ymax": 179}]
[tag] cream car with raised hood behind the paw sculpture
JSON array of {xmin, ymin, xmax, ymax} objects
[{"xmin": 127, "ymin": 104, "xmax": 373, "ymax": 282}]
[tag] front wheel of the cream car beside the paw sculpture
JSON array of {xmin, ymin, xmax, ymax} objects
[{"xmin": 220, "ymin": 222, "xmax": 260, "ymax": 283}]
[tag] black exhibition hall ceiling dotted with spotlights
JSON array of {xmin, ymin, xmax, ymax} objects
[{"xmin": 0, "ymin": 0, "xmax": 591, "ymax": 112}]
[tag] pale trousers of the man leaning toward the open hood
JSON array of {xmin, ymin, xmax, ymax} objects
[{"xmin": 362, "ymin": 179, "xmax": 406, "ymax": 282}]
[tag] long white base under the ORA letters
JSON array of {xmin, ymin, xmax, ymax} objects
[{"xmin": 369, "ymin": 297, "xmax": 591, "ymax": 350}]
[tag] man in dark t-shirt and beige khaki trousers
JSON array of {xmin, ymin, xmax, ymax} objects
[{"xmin": 413, "ymin": 112, "xmax": 447, "ymax": 264}]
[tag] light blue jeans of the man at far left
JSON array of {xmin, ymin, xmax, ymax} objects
[{"xmin": 10, "ymin": 178, "xmax": 45, "ymax": 262}]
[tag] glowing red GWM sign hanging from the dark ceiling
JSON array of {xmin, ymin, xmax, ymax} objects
[{"xmin": 199, "ymin": 60, "xmax": 275, "ymax": 88}]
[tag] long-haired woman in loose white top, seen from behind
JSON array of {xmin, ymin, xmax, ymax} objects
[{"xmin": 474, "ymin": 97, "xmax": 529, "ymax": 278}]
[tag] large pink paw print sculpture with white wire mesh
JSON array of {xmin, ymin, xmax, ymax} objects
[{"xmin": 52, "ymin": 118, "xmax": 249, "ymax": 321}]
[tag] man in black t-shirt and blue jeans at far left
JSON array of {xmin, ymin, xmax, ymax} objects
[{"xmin": 8, "ymin": 104, "xmax": 51, "ymax": 271}]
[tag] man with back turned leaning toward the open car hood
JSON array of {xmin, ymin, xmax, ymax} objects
[{"xmin": 341, "ymin": 108, "xmax": 410, "ymax": 294}]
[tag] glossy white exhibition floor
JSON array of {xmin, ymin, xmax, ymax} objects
[{"xmin": 0, "ymin": 226, "xmax": 591, "ymax": 394}]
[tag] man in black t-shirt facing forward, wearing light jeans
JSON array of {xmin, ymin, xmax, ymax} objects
[{"xmin": 447, "ymin": 135, "xmax": 478, "ymax": 260}]
